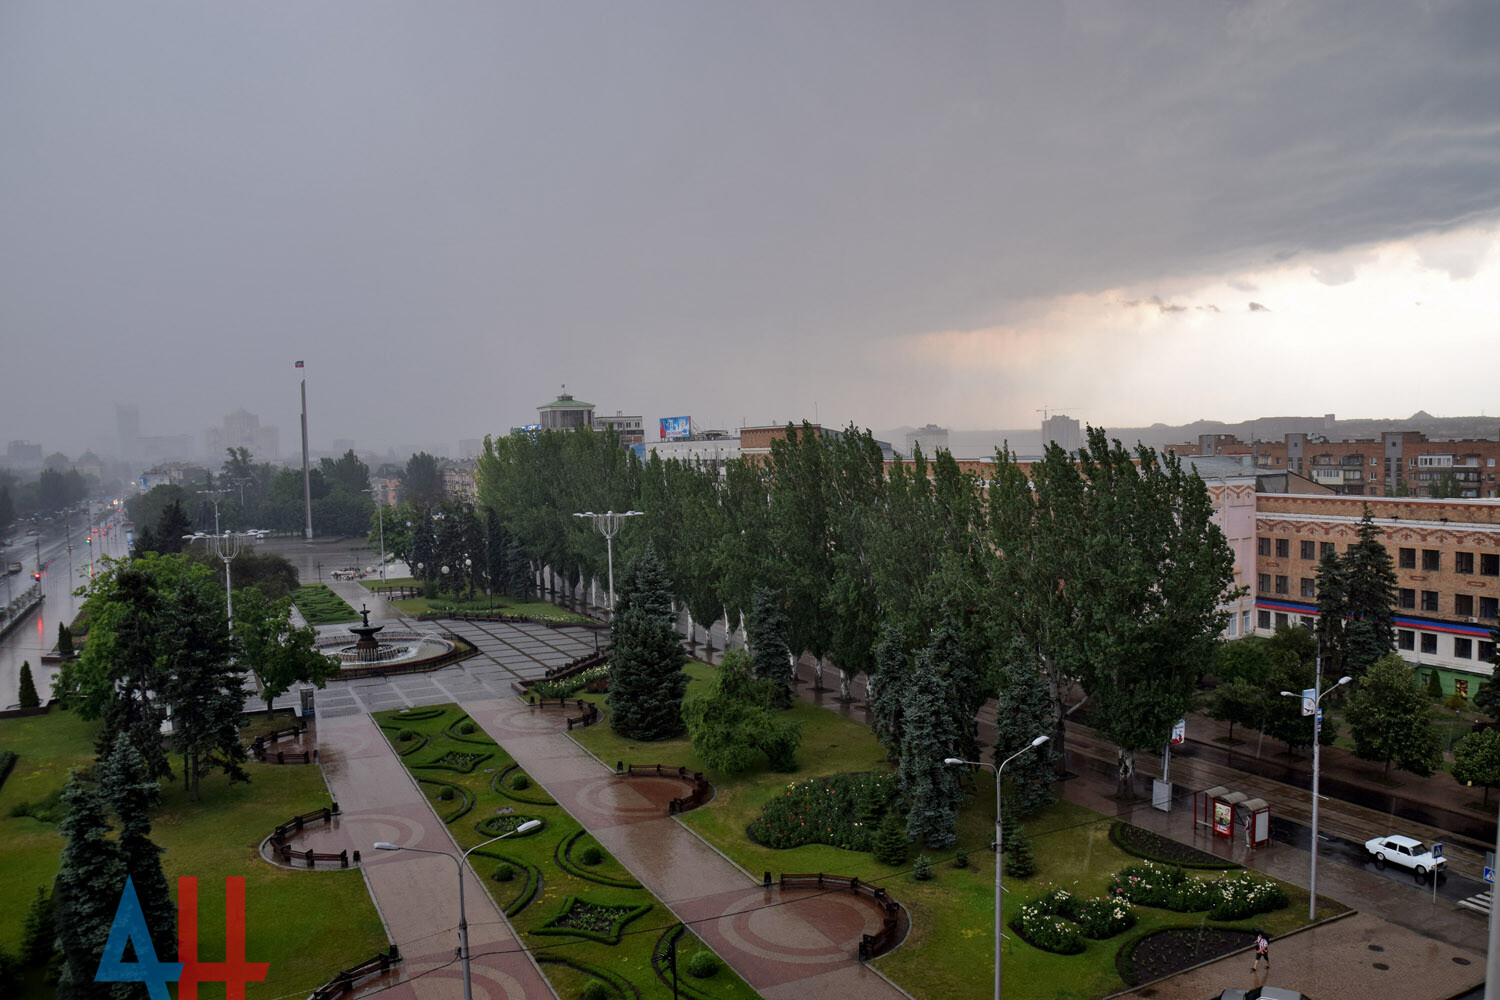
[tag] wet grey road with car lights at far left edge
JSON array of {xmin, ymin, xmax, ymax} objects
[{"xmin": 0, "ymin": 508, "xmax": 128, "ymax": 708}]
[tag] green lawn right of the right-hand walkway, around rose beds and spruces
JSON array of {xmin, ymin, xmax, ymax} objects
[{"xmin": 573, "ymin": 663, "xmax": 1343, "ymax": 1000}]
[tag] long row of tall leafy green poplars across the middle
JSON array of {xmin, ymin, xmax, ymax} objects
[{"xmin": 477, "ymin": 423, "xmax": 1233, "ymax": 784}]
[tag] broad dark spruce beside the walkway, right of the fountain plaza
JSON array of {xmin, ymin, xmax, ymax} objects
[{"xmin": 609, "ymin": 544, "xmax": 687, "ymax": 739}]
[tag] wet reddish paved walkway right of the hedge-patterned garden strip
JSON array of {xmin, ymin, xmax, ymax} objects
[{"xmin": 461, "ymin": 699, "xmax": 903, "ymax": 1000}]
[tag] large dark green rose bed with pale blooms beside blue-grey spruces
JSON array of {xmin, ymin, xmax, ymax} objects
[{"xmin": 747, "ymin": 774, "xmax": 896, "ymax": 850}]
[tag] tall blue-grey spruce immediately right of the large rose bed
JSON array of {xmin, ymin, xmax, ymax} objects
[{"xmin": 899, "ymin": 649, "xmax": 960, "ymax": 849}]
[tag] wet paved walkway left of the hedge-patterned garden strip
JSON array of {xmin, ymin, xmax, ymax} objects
[{"xmin": 318, "ymin": 715, "xmax": 557, "ymax": 1000}]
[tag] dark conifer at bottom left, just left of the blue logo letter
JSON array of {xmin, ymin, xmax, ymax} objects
[{"xmin": 53, "ymin": 774, "xmax": 125, "ymax": 1000}]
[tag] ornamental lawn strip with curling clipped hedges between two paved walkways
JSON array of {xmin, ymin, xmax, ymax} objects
[{"xmin": 375, "ymin": 705, "xmax": 756, "ymax": 1000}]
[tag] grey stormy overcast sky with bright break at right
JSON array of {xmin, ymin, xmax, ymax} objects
[{"xmin": 0, "ymin": 0, "xmax": 1500, "ymax": 453}]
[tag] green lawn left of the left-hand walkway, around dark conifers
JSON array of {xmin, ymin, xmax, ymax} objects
[{"xmin": 0, "ymin": 711, "xmax": 387, "ymax": 1000}]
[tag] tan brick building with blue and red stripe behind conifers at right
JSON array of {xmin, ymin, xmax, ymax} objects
[{"xmin": 1254, "ymin": 493, "xmax": 1500, "ymax": 694}]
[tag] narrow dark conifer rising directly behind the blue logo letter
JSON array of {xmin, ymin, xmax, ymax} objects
[{"xmin": 99, "ymin": 733, "xmax": 177, "ymax": 958}]
